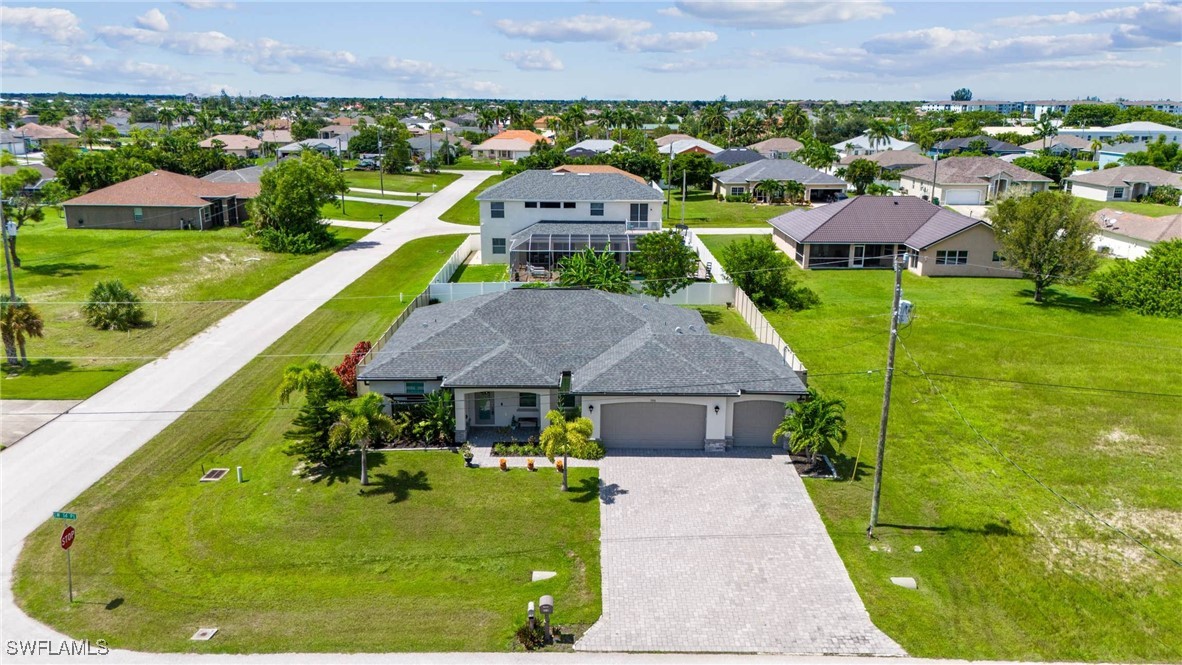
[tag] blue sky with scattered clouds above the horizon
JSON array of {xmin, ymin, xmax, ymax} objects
[{"xmin": 0, "ymin": 0, "xmax": 1182, "ymax": 99}]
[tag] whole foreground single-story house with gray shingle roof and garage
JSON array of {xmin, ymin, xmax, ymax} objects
[{"xmin": 357, "ymin": 288, "xmax": 806, "ymax": 450}]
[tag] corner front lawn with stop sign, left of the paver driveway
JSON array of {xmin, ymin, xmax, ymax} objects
[{"xmin": 14, "ymin": 235, "xmax": 600, "ymax": 653}]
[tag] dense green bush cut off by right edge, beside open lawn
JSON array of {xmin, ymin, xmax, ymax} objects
[{"xmin": 1093, "ymin": 240, "xmax": 1182, "ymax": 318}]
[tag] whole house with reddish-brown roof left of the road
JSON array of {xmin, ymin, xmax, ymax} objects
[{"xmin": 61, "ymin": 171, "xmax": 259, "ymax": 230}]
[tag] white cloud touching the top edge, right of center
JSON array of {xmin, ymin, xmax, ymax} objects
[{"xmin": 677, "ymin": 0, "xmax": 895, "ymax": 30}]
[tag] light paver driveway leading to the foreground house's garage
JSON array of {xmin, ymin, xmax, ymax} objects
[{"xmin": 574, "ymin": 451, "xmax": 904, "ymax": 656}]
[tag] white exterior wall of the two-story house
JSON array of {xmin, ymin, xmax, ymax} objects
[{"xmin": 479, "ymin": 199, "xmax": 662, "ymax": 263}]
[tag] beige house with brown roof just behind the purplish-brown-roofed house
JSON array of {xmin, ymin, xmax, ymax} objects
[{"xmin": 898, "ymin": 157, "xmax": 1051, "ymax": 206}]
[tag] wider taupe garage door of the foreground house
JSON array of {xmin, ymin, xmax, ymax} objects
[{"xmin": 599, "ymin": 402, "xmax": 706, "ymax": 450}]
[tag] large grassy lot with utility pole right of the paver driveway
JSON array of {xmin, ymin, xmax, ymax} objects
[{"xmin": 747, "ymin": 265, "xmax": 1182, "ymax": 663}]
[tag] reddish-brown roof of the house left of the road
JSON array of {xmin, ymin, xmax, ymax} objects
[{"xmin": 63, "ymin": 171, "xmax": 259, "ymax": 208}]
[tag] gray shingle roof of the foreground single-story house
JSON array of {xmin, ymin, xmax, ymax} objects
[{"xmin": 359, "ymin": 288, "xmax": 805, "ymax": 395}]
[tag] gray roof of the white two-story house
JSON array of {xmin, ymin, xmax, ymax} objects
[{"xmin": 476, "ymin": 170, "xmax": 664, "ymax": 201}]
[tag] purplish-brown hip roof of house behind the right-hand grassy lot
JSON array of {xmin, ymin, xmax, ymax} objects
[{"xmin": 768, "ymin": 196, "xmax": 983, "ymax": 249}]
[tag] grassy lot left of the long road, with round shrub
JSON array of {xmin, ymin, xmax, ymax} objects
[{"xmin": 0, "ymin": 208, "xmax": 366, "ymax": 399}]
